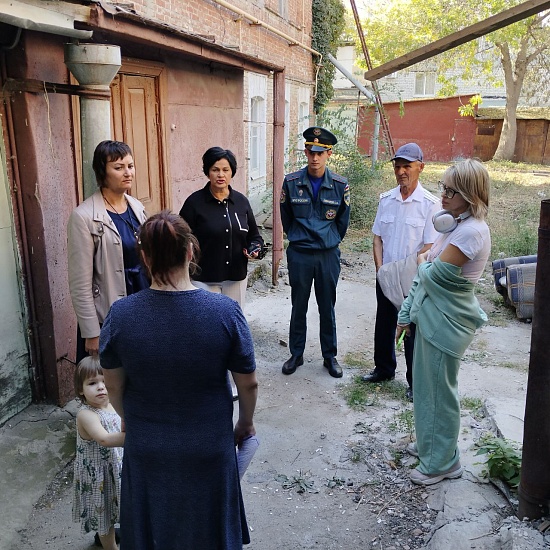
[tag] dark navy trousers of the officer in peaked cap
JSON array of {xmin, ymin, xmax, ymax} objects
[{"xmin": 286, "ymin": 246, "xmax": 340, "ymax": 358}]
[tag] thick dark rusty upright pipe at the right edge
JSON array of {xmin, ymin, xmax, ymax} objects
[{"xmin": 518, "ymin": 199, "xmax": 550, "ymax": 519}]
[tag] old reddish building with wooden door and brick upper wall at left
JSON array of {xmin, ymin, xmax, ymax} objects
[{"xmin": 0, "ymin": 0, "xmax": 315, "ymax": 423}]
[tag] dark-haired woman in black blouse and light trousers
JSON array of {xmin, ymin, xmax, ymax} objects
[{"xmin": 180, "ymin": 147, "xmax": 264, "ymax": 307}]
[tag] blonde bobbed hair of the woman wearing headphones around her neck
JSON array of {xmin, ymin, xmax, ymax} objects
[{"xmin": 443, "ymin": 159, "xmax": 490, "ymax": 220}]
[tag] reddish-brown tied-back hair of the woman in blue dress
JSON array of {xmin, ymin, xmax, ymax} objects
[{"xmin": 139, "ymin": 210, "xmax": 200, "ymax": 287}]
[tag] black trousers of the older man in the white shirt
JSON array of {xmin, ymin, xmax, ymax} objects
[{"xmin": 374, "ymin": 281, "xmax": 416, "ymax": 388}]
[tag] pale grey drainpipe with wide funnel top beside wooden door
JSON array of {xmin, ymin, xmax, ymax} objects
[{"xmin": 65, "ymin": 44, "xmax": 121, "ymax": 198}]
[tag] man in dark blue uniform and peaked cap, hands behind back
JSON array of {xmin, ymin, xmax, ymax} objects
[{"xmin": 281, "ymin": 127, "xmax": 350, "ymax": 378}]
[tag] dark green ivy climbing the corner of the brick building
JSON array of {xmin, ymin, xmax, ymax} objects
[{"xmin": 311, "ymin": 0, "xmax": 345, "ymax": 113}]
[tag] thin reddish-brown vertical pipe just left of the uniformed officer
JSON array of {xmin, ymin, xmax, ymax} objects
[{"xmin": 271, "ymin": 71, "xmax": 285, "ymax": 285}]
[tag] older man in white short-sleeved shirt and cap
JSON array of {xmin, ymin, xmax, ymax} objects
[{"xmin": 363, "ymin": 143, "xmax": 441, "ymax": 400}]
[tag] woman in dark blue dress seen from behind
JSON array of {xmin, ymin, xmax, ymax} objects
[{"xmin": 100, "ymin": 211, "xmax": 257, "ymax": 550}]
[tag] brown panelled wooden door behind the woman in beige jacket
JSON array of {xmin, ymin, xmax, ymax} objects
[{"xmin": 111, "ymin": 62, "xmax": 167, "ymax": 215}]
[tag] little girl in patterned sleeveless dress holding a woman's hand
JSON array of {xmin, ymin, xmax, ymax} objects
[{"xmin": 73, "ymin": 356, "xmax": 125, "ymax": 550}]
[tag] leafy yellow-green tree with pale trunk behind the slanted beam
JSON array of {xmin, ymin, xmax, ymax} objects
[{"xmin": 363, "ymin": 0, "xmax": 550, "ymax": 160}]
